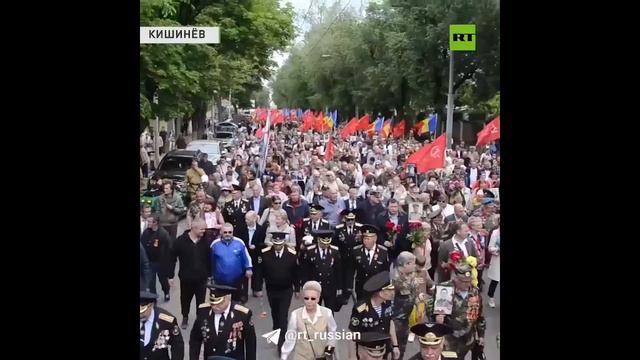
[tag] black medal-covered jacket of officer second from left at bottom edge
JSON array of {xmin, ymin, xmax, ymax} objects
[{"xmin": 189, "ymin": 301, "xmax": 256, "ymax": 360}]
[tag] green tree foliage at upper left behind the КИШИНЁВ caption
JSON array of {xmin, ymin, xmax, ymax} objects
[{"xmin": 140, "ymin": 0, "xmax": 294, "ymax": 131}]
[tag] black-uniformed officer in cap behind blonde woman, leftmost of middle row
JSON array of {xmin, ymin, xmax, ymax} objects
[{"xmin": 256, "ymin": 233, "xmax": 300, "ymax": 352}]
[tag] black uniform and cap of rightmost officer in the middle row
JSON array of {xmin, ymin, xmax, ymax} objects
[{"xmin": 351, "ymin": 224, "xmax": 391, "ymax": 300}]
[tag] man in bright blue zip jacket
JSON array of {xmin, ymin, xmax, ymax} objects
[{"xmin": 211, "ymin": 223, "xmax": 253, "ymax": 303}]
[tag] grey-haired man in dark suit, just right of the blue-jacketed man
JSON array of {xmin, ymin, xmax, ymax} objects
[{"xmin": 233, "ymin": 210, "xmax": 266, "ymax": 302}]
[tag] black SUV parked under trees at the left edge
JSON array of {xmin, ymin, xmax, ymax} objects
[{"xmin": 143, "ymin": 150, "xmax": 204, "ymax": 206}]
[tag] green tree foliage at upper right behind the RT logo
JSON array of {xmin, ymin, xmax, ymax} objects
[{"xmin": 272, "ymin": 0, "xmax": 500, "ymax": 123}]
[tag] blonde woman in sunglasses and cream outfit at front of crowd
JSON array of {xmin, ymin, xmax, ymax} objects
[{"xmin": 280, "ymin": 281, "xmax": 338, "ymax": 360}]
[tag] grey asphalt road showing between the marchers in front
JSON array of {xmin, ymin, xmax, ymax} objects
[{"xmin": 156, "ymin": 221, "xmax": 500, "ymax": 360}]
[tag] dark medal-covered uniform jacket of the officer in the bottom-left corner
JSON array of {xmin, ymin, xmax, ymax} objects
[{"xmin": 140, "ymin": 306, "xmax": 184, "ymax": 360}]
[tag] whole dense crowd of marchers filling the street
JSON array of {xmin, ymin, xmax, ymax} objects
[{"xmin": 140, "ymin": 124, "xmax": 500, "ymax": 360}]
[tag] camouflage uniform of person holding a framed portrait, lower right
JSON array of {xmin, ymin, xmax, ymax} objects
[{"xmin": 427, "ymin": 262, "xmax": 486, "ymax": 359}]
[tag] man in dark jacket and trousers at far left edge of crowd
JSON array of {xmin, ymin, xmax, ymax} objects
[{"xmin": 140, "ymin": 215, "xmax": 172, "ymax": 302}]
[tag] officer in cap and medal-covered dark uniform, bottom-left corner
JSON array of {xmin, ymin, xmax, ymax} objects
[{"xmin": 140, "ymin": 291, "xmax": 184, "ymax": 360}]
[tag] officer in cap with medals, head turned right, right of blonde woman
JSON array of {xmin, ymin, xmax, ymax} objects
[{"xmin": 349, "ymin": 271, "xmax": 400, "ymax": 360}]
